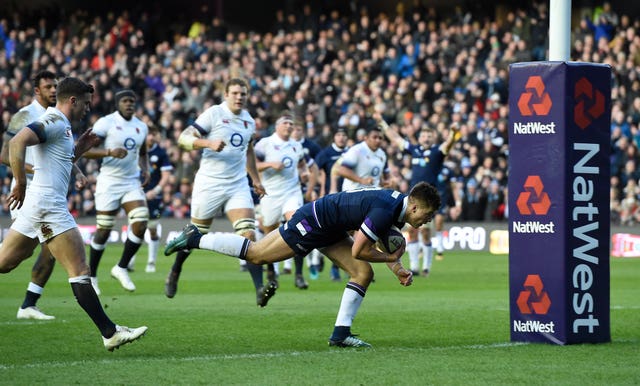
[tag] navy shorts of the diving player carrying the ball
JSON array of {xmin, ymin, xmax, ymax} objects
[{"xmin": 279, "ymin": 202, "xmax": 350, "ymax": 256}]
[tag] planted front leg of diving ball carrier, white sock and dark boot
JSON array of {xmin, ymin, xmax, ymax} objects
[{"xmin": 320, "ymin": 237, "xmax": 373, "ymax": 347}]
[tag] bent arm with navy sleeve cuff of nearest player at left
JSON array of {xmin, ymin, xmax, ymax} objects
[{"xmin": 8, "ymin": 126, "xmax": 40, "ymax": 209}]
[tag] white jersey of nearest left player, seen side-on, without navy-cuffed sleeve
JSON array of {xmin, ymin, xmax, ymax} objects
[{"xmin": 29, "ymin": 107, "xmax": 74, "ymax": 201}]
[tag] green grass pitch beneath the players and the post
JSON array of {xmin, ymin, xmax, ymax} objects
[{"xmin": 0, "ymin": 244, "xmax": 640, "ymax": 385}]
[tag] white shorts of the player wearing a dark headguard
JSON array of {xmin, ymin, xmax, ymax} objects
[{"xmin": 95, "ymin": 178, "xmax": 147, "ymax": 212}]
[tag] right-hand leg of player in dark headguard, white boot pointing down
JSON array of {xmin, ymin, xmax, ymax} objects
[{"xmin": 111, "ymin": 199, "xmax": 149, "ymax": 291}]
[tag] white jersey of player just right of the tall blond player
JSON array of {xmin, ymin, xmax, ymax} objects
[{"xmin": 255, "ymin": 133, "xmax": 304, "ymax": 196}]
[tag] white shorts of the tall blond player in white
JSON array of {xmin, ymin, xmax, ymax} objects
[{"xmin": 191, "ymin": 174, "xmax": 254, "ymax": 220}]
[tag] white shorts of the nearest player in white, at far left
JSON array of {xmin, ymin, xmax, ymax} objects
[{"xmin": 11, "ymin": 193, "xmax": 78, "ymax": 243}]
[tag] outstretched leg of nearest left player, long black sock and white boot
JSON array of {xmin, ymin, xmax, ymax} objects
[{"xmin": 48, "ymin": 227, "xmax": 147, "ymax": 351}]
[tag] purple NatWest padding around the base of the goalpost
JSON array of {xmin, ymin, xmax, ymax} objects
[{"xmin": 509, "ymin": 62, "xmax": 611, "ymax": 344}]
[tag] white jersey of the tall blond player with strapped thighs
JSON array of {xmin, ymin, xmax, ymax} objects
[{"xmin": 192, "ymin": 102, "xmax": 256, "ymax": 183}]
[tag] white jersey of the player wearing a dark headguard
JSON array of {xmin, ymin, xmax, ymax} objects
[{"xmin": 93, "ymin": 111, "xmax": 149, "ymax": 179}]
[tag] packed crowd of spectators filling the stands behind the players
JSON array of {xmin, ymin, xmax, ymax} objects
[{"xmin": 0, "ymin": 1, "xmax": 640, "ymax": 224}]
